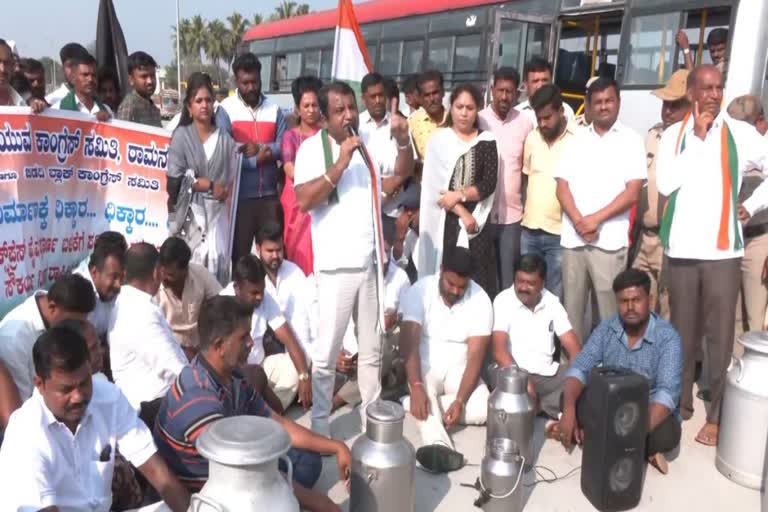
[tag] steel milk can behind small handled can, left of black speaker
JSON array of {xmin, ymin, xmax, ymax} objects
[{"xmin": 485, "ymin": 365, "xmax": 534, "ymax": 469}]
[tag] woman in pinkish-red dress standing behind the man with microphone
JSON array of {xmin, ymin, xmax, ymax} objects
[{"xmin": 280, "ymin": 76, "xmax": 323, "ymax": 275}]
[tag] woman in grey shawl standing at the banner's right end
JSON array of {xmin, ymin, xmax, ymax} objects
[{"xmin": 167, "ymin": 73, "xmax": 240, "ymax": 286}]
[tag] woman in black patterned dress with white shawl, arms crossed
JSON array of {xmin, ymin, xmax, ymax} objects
[{"xmin": 417, "ymin": 84, "xmax": 499, "ymax": 300}]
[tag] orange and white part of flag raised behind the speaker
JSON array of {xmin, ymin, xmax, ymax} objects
[{"xmin": 331, "ymin": 0, "xmax": 373, "ymax": 93}]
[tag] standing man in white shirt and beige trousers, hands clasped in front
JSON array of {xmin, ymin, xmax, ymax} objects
[{"xmin": 555, "ymin": 77, "xmax": 647, "ymax": 339}]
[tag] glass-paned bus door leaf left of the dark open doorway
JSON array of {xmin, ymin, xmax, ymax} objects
[{"xmin": 485, "ymin": 10, "xmax": 555, "ymax": 102}]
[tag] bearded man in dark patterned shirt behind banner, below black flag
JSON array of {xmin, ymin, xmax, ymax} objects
[{"xmin": 117, "ymin": 52, "xmax": 163, "ymax": 128}]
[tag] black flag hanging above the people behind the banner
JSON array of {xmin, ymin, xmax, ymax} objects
[{"xmin": 96, "ymin": 0, "xmax": 128, "ymax": 96}]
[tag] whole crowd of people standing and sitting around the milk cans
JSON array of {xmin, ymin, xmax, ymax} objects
[{"xmin": 0, "ymin": 26, "xmax": 768, "ymax": 511}]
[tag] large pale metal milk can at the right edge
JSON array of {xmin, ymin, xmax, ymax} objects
[{"xmin": 715, "ymin": 332, "xmax": 768, "ymax": 489}]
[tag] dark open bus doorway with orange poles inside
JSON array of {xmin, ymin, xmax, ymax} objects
[{"xmin": 554, "ymin": 0, "xmax": 624, "ymax": 115}]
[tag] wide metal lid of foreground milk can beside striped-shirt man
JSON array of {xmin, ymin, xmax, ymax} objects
[{"xmin": 196, "ymin": 416, "xmax": 291, "ymax": 466}]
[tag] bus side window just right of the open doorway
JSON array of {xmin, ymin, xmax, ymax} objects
[{"xmin": 624, "ymin": 12, "xmax": 681, "ymax": 85}]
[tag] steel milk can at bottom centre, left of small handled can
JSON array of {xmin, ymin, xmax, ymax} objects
[{"xmin": 352, "ymin": 400, "xmax": 416, "ymax": 512}]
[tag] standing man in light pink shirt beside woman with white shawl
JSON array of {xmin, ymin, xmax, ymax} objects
[{"xmin": 480, "ymin": 67, "xmax": 533, "ymax": 290}]
